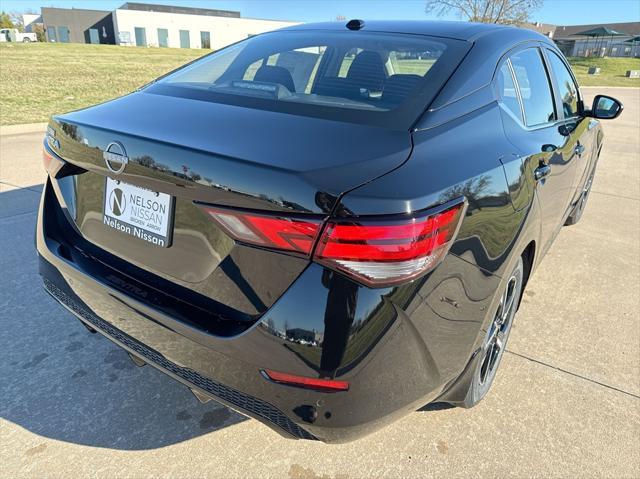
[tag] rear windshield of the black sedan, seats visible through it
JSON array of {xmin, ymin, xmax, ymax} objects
[{"xmin": 147, "ymin": 31, "xmax": 466, "ymax": 128}]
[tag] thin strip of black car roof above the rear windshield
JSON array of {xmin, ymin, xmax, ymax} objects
[{"xmin": 282, "ymin": 20, "xmax": 545, "ymax": 41}]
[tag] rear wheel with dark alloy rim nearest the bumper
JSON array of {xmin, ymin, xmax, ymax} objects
[{"xmin": 458, "ymin": 257, "xmax": 524, "ymax": 408}]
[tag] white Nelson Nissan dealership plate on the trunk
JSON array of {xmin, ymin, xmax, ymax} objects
[{"xmin": 103, "ymin": 178, "xmax": 173, "ymax": 248}]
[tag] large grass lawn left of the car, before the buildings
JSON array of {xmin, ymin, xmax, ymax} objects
[{"xmin": 0, "ymin": 43, "xmax": 209, "ymax": 125}]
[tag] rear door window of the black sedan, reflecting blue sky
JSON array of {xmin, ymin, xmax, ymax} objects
[{"xmin": 510, "ymin": 48, "xmax": 556, "ymax": 126}]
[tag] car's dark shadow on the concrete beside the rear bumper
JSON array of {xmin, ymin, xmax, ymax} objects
[{"xmin": 0, "ymin": 187, "xmax": 244, "ymax": 450}]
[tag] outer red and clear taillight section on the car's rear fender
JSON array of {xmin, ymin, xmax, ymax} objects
[{"xmin": 314, "ymin": 202, "xmax": 466, "ymax": 286}]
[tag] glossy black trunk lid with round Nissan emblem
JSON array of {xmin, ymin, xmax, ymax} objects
[{"xmin": 49, "ymin": 92, "xmax": 411, "ymax": 332}]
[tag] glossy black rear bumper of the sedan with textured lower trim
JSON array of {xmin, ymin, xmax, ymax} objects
[{"xmin": 36, "ymin": 182, "xmax": 499, "ymax": 442}]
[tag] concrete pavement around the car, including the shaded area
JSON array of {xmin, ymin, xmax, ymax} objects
[{"xmin": 0, "ymin": 88, "xmax": 640, "ymax": 478}]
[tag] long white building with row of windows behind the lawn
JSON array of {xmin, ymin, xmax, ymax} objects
[{"xmin": 112, "ymin": 3, "xmax": 296, "ymax": 50}]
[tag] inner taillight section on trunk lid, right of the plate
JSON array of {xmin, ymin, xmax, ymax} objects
[{"xmin": 204, "ymin": 207, "xmax": 322, "ymax": 255}]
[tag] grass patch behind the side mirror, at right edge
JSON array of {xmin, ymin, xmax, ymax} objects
[{"xmin": 568, "ymin": 57, "xmax": 640, "ymax": 87}]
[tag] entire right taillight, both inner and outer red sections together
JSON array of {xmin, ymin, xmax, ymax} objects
[{"xmin": 203, "ymin": 200, "xmax": 466, "ymax": 287}]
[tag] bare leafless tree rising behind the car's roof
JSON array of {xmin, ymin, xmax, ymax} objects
[{"xmin": 425, "ymin": 0, "xmax": 543, "ymax": 24}]
